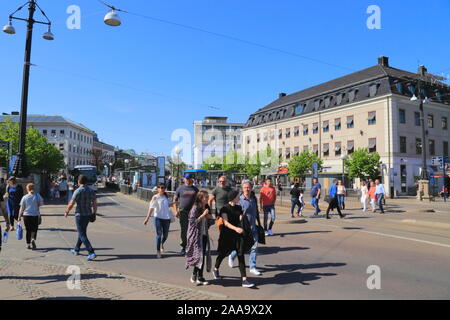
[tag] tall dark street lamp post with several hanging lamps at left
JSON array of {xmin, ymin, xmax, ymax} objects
[{"xmin": 3, "ymin": 0, "xmax": 55, "ymax": 178}]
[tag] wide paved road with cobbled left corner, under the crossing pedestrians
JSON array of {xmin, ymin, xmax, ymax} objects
[{"xmin": 0, "ymin": 188, "xmax": 450, "ymax": 300}]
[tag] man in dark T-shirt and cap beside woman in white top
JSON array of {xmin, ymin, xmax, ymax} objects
[{"xmin": 174, "ymin": 173, "xmax": 198, "ymax": 256}]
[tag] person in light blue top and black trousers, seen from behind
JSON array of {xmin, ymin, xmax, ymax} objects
[{"xmin": 18, "ymin": 183, "xmax": 44, "ymax": 250}]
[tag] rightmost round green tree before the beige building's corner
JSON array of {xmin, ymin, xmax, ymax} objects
[{"xmin": 344, "ymin": 149, "xmax": 381, "ymax": 180}]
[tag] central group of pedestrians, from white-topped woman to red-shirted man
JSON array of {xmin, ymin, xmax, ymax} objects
[{"xmin": 144, "ymin": 173, "xmax": 270, "ymax": 287}]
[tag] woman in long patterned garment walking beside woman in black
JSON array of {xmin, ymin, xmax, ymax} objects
[{"xmin": 186, "ymin": 191, "xmax": 214, "ymax": 285}]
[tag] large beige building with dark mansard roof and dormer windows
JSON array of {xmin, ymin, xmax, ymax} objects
[{"xmin": 242, "ymin": 57, "xmax": 450, "ymax": 194}]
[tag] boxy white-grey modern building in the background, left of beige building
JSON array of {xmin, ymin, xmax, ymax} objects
[{"xmin": 193, "ymin": 117, "xmax": 244, "ymax": 169}]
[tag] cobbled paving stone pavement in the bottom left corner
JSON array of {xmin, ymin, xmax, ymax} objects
[{"xmin": 0, "ymin": 259, "xmax": 227, "ymax": 300}]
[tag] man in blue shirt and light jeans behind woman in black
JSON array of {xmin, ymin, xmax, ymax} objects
[{"xmin": 228, "ymin": 180, "xmax": 261, "ymax": 276}]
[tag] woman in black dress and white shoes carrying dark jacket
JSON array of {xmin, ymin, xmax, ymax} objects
[{"xmin": 213, "ymin": 190, "xmax": 254, "ymax": 288}]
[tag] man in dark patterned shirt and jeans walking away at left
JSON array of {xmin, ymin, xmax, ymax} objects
[{"xmin": 64, "ymin": 175, "xmax": 97, "ymax": 261}]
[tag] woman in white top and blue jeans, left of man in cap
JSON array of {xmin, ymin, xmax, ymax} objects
[{"xmin": 144, "ymin": 183, "xmax": 173, "ymax": 259}]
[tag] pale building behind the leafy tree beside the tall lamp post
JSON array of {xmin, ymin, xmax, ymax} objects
[{"xmin": 0, "ymin": 115, "xmax": 94, "ymax": 170}]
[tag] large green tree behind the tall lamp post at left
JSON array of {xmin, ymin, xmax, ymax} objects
[{"xmin": 0, "ymin": 119, "xmax": 66, "ymax": 173}]
